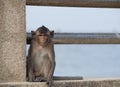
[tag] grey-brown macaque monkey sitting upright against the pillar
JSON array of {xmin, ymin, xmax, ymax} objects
[{"xmin": 28, "ymin": 26, "xmax": 55, "ymax": 87}]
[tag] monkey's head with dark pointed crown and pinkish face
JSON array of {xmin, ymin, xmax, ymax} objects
[{"xmin": 31, "ymin": 26, "xmax": 54, "ymax": 45}]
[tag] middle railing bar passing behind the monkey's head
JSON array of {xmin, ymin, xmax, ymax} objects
[{"xmin": 27, "ymin": 33, "xmax": 120, "ymax": 44}]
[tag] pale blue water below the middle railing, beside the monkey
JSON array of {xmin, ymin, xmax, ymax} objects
[{"xmin": 26, "ymin": 45, "xmax": 120, "ymax": 77}]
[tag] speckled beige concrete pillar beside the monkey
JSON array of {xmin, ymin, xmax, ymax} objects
[{"xmin": 0, "ymin": 0, "xmax": 26, "ymax": 83}]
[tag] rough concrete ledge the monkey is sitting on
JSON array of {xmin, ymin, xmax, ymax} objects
[{"xmin": 0, "ymin": 78, "xmax": 120, "ymax": 87}]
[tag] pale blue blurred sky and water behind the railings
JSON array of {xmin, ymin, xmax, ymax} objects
[{"xmin": 26, "ymin": 6, "xmax": 120, "ymax": 77}]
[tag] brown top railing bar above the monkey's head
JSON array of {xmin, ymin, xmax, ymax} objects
[{"xmin": 26, "ymin": 0, "xmax": 120, "ymax": 8}]
